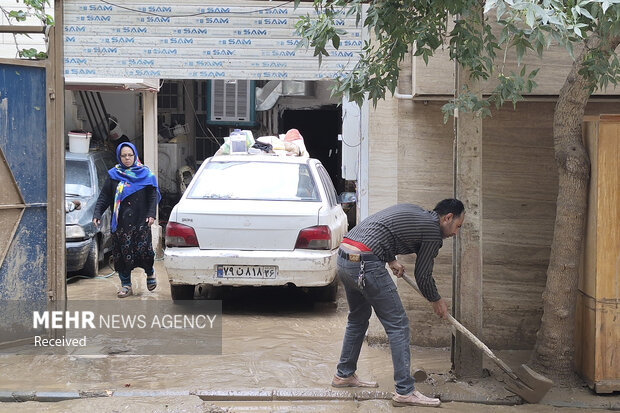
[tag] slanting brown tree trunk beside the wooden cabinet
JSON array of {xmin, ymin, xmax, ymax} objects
[{"xmin": 530, "ymin": 39, "xmax": 618, "ymax": 385}]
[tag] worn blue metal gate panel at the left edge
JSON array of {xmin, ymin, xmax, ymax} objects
[{"xmin": 0, "ymin": 64, "xmax": 48, "ymax": 301}]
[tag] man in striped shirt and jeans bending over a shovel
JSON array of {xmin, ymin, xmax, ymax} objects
[{"xmin": 332, "ymin": 199, "xmax": 465, "ymax": 407}]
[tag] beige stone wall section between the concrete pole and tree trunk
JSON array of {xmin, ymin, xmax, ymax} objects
[{"xmin": 482, "ymin": 103, "xmax": 557, "ymax": 348}]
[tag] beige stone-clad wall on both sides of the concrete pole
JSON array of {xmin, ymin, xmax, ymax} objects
[{"xmin": 369, "ymin": 98, "xmax": 620, "ymax": 349}]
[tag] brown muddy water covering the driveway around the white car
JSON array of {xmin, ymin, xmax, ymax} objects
[{"xmin": 0, "ymin": 263, "xmax": 398, "ymax": 391}]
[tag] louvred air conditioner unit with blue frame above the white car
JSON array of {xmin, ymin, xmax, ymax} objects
[{"xmin": 207, "ymin": 80, "xmax": 256, "ymax": 126}]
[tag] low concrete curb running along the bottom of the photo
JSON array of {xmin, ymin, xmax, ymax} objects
[{"xmin": 0, "ymin": 389, "xmax": 620, "ymax": 411}]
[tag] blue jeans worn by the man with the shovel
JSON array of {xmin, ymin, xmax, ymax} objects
[{"xmin": 337, "ymin": 256, "xmax": 414, "ymax": 395}]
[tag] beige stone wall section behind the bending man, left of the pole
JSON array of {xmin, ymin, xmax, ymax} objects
[{"xmin": 390, "ymin": 100, "xmax": 454, "ymax": 346}]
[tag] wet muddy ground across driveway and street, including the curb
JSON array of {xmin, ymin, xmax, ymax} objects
[{"xmin": 0, "ymin": 261, "xmax": 620, "ymax": 413}]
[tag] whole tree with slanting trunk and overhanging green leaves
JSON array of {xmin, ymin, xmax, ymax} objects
[{"xmin": 296, "ymin": 0, "xmax": 620, "ymax": 382}]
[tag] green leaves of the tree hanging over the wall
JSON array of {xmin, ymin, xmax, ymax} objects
[{"xmin": 296, "ymin": 0, "xmax": 620, "ymax": 120}]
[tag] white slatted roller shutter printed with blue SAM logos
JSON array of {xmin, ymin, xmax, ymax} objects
[{"xmin": 64, "ymin": 0, "xmax": 364, "ymax": 80}]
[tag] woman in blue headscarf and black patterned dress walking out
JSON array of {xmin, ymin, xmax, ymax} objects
[{"xmin": 93, "ymin": 142, "xmax": 161, "ymax": 298}]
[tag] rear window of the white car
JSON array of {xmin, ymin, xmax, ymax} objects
[{"xmin": 188, "ymin": 162, "xmax": 320, "ymax": 201}]
